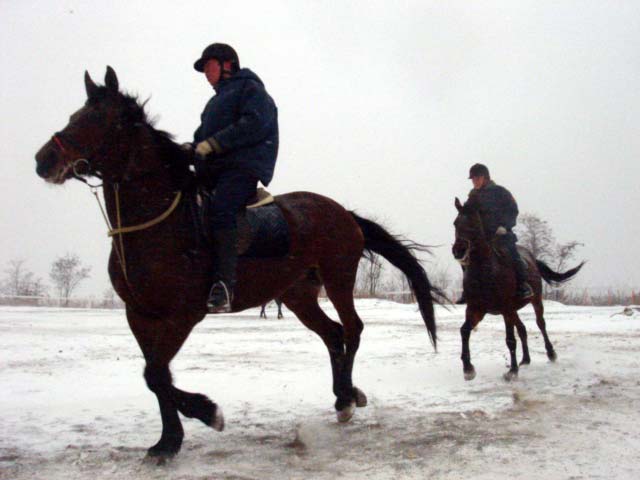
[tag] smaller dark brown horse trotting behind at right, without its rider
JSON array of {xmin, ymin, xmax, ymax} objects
[{"xmin": 453, "ymin": 198, "xmax": 584, "ymax": 380}]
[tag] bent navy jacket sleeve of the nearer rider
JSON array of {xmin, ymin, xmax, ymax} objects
[{"xmin": 213, "ymin": 82, "xmax": 276, "ymax": 152}]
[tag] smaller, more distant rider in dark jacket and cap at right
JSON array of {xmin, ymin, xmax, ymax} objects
[{"xmin": 463, "ymin": 163, "xmax": 533, "ymax": 299}]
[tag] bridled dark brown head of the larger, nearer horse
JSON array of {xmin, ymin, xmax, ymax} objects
[{"xmin": 36, "ymin": 67, "xmax": 145, "ymax": 184}]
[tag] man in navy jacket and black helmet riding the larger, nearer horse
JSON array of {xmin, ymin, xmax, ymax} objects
[{"xmin": 193, "ymin": 43, "xmax": 278, "ymax": 313}]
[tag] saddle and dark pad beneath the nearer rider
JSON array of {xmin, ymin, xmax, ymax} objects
[{"xmin": 196, "ymin": 188, "xmax": 290, "ymax": 258}]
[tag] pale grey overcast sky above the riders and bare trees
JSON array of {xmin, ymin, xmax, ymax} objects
[{"xmin": 0, "ymin": 0, "xmax": 640, "ymax": 295}]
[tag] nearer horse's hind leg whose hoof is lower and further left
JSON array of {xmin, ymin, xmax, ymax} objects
[{"xmin": 281, "ymin": 274, "xmax": 360, "ymax": 421}]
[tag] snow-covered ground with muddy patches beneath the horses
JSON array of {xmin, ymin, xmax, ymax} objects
[{"xmin": 0, "ymin": 300, "xmax": 640, "ymax": 480}]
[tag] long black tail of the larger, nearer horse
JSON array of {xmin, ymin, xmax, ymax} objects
[{"xmin": 349, "ymin": 212, "xmax": 446, "ymax": 348}]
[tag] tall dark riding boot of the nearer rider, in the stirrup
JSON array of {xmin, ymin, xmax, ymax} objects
[{"xmin": 207, "ymin": 228, "xmax": 238, "ymax": 313}]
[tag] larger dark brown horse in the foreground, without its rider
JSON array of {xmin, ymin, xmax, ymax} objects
[{"xmin": 36, "ymin": 67, "xmax": 436, "ymax": 457}]
